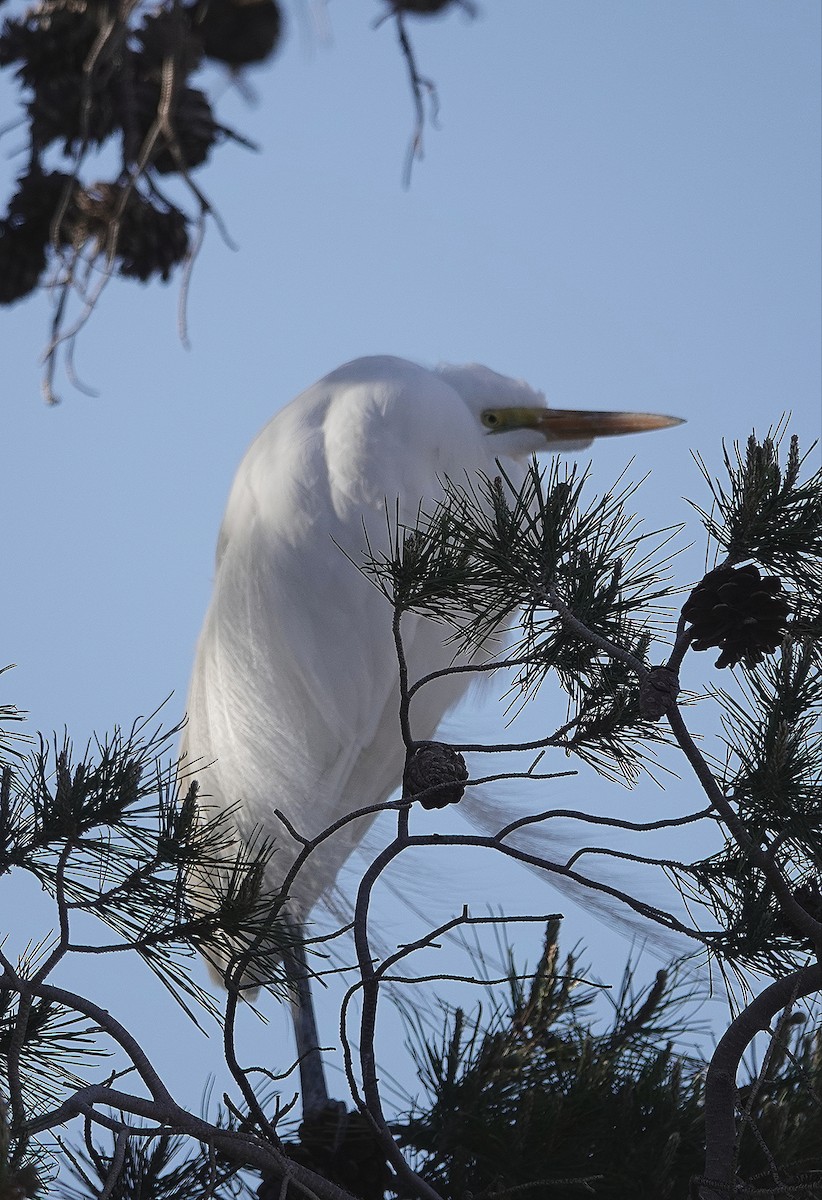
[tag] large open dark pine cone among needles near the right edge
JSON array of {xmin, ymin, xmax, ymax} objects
[{"xmin": 682, "ymin": 563, "xmax": 788, "ymax": 667}]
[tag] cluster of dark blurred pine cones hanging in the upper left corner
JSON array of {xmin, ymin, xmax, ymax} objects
[{"xmin": 0, "ymin": 0, "xmax": 282, "ymax": 305}]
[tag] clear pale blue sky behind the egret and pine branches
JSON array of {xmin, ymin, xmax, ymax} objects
[{"xmin": 0, "ymin": 0, "xmax": 822, "ymax": 1132}]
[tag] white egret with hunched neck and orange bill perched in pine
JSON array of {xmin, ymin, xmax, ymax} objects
[{"xmin": 184, "ymin": 356, "xmax": 678, "ymax": 1113}]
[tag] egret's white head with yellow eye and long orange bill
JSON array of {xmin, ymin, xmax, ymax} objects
[{"xmin": 437, "ymin": 364, "xmax": 682, "ymax": 457}]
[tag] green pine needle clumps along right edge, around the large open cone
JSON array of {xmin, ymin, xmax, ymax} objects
[{"xmin": 678, "ymin": 432, "xmax": 822, "ymax": 976}]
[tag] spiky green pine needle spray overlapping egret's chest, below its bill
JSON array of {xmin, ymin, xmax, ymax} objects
[{"xmin": 358, "ymin": 460, "xmax": 674, "ymax": 784}]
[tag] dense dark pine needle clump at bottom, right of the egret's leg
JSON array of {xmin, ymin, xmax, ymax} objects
[{"xmin": 400, "ymin": 929, "xmax": 703, "ymax": 1200}]
